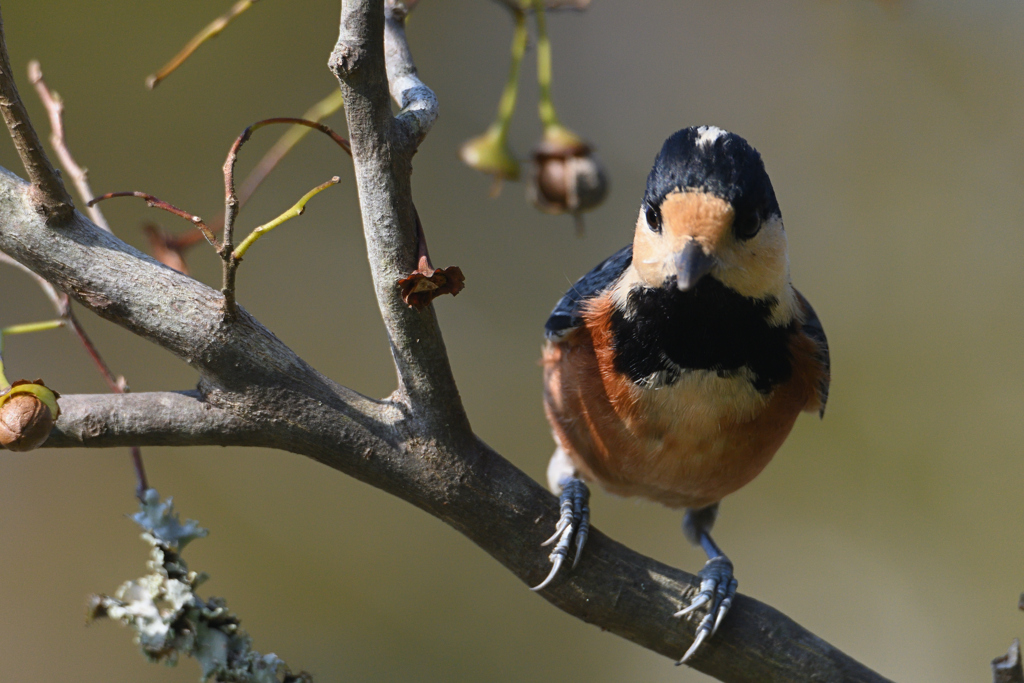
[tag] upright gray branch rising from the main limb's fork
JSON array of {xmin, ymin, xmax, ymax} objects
[{"xmin": 328, "ymin": 1, "xmax": 469, "ymax": 433}]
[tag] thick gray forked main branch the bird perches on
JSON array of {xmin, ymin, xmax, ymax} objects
[{"xmin": 0, "ymin": 0, "xmax": 886, "ymax": 683}]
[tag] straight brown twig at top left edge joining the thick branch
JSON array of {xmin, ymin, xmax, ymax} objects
[{"xmin": 0, "ymin": 8, "xmax": 75, "ymax": 221}]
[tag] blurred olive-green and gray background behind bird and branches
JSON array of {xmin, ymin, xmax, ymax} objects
[{"xmin": 0, "ymin": 0, "xmax": 1024, "ymax": 683}]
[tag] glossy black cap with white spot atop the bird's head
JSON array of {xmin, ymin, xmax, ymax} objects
[{"xmin": 644, "ymin": 126, "xmax": 781, "ymax": 237}]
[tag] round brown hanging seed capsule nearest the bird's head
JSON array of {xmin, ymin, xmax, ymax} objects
[{"xmin": 526, "ymin": 126, "xmax": 608, "ymax": 216}]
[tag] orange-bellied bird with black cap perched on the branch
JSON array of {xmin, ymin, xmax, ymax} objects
[{"xmin": 534, "ymin": 126, "xmax": 830, "ymax": 664}]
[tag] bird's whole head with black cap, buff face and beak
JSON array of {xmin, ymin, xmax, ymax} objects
[{"xmin": 631, "ymin": 126, "xmax": 795, "ymax": 321}]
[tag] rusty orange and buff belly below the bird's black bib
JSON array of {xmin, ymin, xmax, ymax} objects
[{"xmin": 545, "ymin": 345, "xmax": 806, "ymax": 508}]
